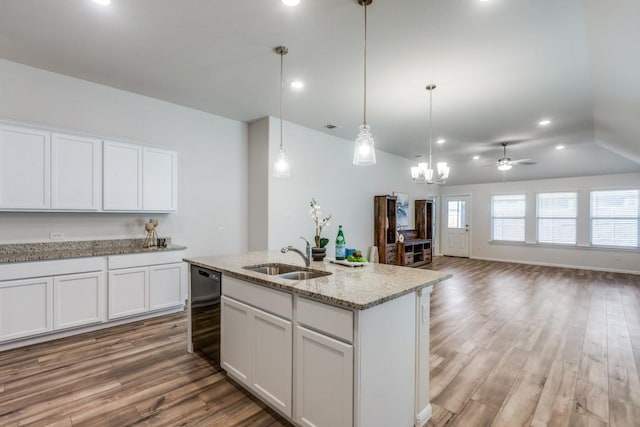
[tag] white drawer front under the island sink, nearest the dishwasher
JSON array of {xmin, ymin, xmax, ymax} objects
[{"xmin": 222, "ymin": 276, "xmax": 293, "ymax": 319}]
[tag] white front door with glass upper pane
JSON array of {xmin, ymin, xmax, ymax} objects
[{"xmin": 442, "ymin": 196, "xmax": 471, "ymax": 258}]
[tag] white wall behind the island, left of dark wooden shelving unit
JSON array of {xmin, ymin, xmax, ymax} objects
[{"xmin": 250, "ymin": 118, "xmax": 437, "ymax": 257}]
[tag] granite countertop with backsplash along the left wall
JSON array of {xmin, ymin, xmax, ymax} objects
[{"xmin": 0, "ymin": 239, "xmax": 186, "ymax": 264}]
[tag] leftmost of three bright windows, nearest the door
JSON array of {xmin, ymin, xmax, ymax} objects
[{"xmin": 491, "ymin": 194, "xmax": 526, "ymax": 242}]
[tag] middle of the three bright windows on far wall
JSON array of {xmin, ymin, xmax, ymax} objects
[{"xmin": 537, "ymin": 193, "xmax": 578, "ymax": 245}]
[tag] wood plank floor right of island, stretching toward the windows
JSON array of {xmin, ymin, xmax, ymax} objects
[{"xmin": 428, "ymin": 257, "xmax": 640, "ymax": 427}]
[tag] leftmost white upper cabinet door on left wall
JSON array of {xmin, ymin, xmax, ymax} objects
[{"xmin": 0, "ymin": 125, "xmax": 51, "ymax": 209}]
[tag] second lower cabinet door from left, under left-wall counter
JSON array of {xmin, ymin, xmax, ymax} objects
[{"xmin": 53, "ymin": 272, "xmax": 104, "ymax": 330}]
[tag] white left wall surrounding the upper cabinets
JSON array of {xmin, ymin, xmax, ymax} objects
[{"xmin": 0, "ymin": 60, "xmax": 248, "ymax": 255}]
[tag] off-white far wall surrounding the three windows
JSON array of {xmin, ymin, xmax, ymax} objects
[{"xmin": 441, "ymin": 173, "xmax": 640, "ymax": 273}]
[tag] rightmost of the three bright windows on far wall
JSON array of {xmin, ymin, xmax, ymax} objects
[{"xmin": 591, "ymin": 190, "xmax": 640, "ymax": 248}]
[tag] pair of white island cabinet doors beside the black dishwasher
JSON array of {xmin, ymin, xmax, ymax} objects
[{"xmin": 221, "ymin": 294, "xmax": 293, "ymax": 417}]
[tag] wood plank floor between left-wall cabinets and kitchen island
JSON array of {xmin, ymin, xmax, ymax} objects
[{"xmin": 0, "ymin": 313, "xmax": 290, "ymax": 427}]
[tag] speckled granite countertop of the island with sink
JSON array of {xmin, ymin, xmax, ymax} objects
[{"xmin": 184, "ymin": 251, "xmax": 452, "ymax": 310}]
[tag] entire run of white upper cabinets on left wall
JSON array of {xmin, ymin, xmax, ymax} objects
[{"xmin": 0, "ymin": 122, "xmax": 178, "ymax": 212}]
